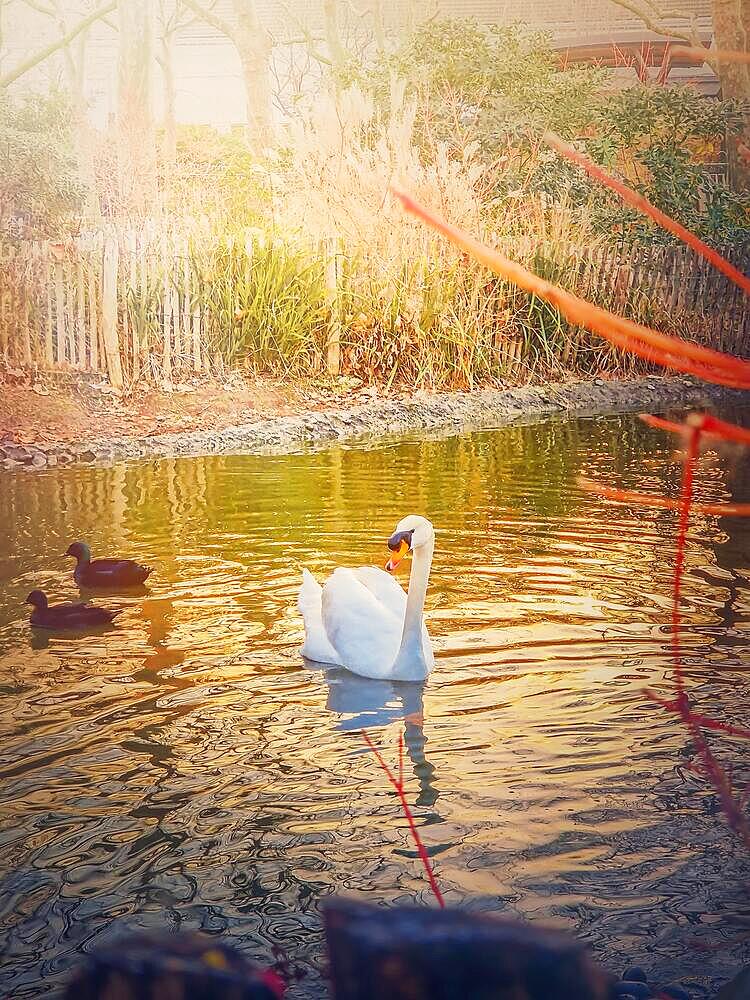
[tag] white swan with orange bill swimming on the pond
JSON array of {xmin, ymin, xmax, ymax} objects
[{"xmin": 297, "ymin": 514, "xmax": 435, "ymax": 681}]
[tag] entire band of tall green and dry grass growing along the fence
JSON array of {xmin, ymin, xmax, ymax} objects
[{"xmin": 2, "ymin": 79, "xmax": 708, "ymax": 389}]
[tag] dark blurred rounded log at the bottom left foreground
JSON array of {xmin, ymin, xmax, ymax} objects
[{"xmin": 65, "ymin": 933, "xmax": 282, "ymax": 1000}]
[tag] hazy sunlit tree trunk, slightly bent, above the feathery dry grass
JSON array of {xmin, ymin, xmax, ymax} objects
[{"xmin": 232, "ymin": 0, "xmax": 273, "ymax": 151}]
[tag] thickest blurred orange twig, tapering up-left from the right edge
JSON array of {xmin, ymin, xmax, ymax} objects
[{"xmin": 394, "ymin": 190, "xmax": 750, "ymax": 388}]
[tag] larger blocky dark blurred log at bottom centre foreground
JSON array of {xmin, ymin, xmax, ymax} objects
[{"xmin": 325, "ymin": 899, "xmax": 612, "ymax": 1000}]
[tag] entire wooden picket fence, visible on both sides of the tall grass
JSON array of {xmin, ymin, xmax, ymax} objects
[{"xmin": 0, "ymin": 230, "xmax": 750, "ymax": 389}]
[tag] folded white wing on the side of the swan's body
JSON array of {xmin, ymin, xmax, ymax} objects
[{"xmin": 322, "ymin": 569, "xmax": 403, "ymax": 678}]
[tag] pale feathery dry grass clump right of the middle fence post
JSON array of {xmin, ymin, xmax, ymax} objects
[{"xmin": 264, "ymin": 79, "xmax": 636, "ymax": 388}]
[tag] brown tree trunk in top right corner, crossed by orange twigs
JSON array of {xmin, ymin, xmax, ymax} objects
[{"xmin": 713, "ymin": 0, "xmax": 750, "ymax": 191}]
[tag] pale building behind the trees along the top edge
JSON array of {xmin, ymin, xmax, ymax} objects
[{"xmin": 0, "ymin": 0, "xmax": 718, "ymax": 129}]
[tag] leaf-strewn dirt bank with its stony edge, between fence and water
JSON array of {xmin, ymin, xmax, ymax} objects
[{"xmin": 0, "ymin": 376, "xmax": 750, "ymax": 469}]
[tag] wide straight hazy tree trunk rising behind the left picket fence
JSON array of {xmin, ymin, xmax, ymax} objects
[{"xmin": 117, "ymin": 0, "xmax": 155, "ymax": 215}]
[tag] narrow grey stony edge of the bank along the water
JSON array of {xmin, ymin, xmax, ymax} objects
[{"xmin": 0, "ymin": 375, "xmax": 750, "ymax": 471}]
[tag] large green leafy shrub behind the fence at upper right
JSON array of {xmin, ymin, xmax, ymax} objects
[{"xmin": 364, "ymin": 20, "xmax": 750, "ymax": 243}]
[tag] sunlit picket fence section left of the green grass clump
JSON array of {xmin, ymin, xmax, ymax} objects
[{"xmin": 0, "ymin": 232, "xmax": 211, "ymax": 389}]
